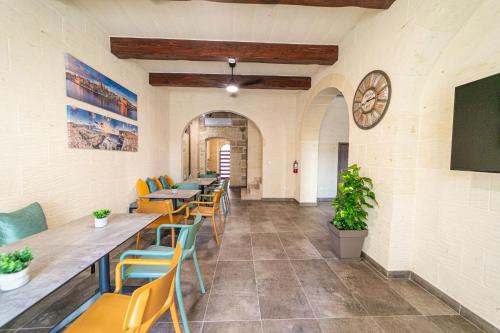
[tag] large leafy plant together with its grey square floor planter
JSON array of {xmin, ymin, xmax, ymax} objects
[{"xmin": 328, "ymin": 164, "xmax": 377, "ymax": 259}]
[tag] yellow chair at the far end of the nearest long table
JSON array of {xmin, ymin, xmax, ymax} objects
[{"xmin": 135, "ymin": 199, "xmax": 189, "ymax": 250}]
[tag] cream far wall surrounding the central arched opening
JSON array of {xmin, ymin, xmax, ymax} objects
[{"xmin": 164, "ymin": 88, "xmax": 296, "ymax": 198}]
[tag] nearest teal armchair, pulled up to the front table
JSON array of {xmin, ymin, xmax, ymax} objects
[{"xmin": 120, "ymin": 215, "xmax": 205, "ymax": 333}]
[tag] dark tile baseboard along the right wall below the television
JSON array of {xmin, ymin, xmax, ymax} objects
[{"xmin": 361, "ymin": 252, "xmax": 500, "ymax": 333}]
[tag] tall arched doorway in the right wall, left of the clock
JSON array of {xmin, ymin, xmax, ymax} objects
[{"xmin": 297, "ymin": 75, "xmax": 353, "ymax": 205}]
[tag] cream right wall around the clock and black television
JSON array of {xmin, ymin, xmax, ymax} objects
[{"xmin": 295, "ymin": 0, "xmax": 500, "ymax": 326}]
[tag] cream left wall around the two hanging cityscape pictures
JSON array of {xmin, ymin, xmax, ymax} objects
[{"xmin": 0, "ymin": 0, "xmax": 169, "ymax": 227}]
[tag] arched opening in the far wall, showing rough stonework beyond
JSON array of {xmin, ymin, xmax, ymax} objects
[{"xmin": 182, "ymin": 111, "xmax": 263, "ymax": 200}]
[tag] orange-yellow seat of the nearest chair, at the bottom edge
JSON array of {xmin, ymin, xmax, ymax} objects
[{"xmin": 65, "ymin": 293, "xmax": 130, "ymax": 333}]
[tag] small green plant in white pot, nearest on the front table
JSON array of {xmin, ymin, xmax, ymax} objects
[{"xmin": 0, "ymin": 248, "xmax": 33, "ymax": 291}]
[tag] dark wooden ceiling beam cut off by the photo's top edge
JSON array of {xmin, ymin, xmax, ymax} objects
[{"xmin": 205, "ymin": 0, "xmax": 396, "ymax": 9}]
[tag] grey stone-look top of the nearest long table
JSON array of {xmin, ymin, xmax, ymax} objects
[{"xmin": 0, "ymin": 214, "xmax": 161, "ymax": 327}]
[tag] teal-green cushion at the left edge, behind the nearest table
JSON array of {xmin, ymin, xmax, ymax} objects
[{"xmin": 0, "ymin": 202, "xmax": 47, "ymax": 246}]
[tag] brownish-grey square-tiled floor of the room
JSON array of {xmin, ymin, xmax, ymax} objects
[{"xmin": 0, "ymin": 195, "xmax": 480, "ymax": 333}]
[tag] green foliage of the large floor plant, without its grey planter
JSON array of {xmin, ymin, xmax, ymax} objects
[{"xmin": 332, "ymin": 164, "xmax": 378, "ymax": 230}]
